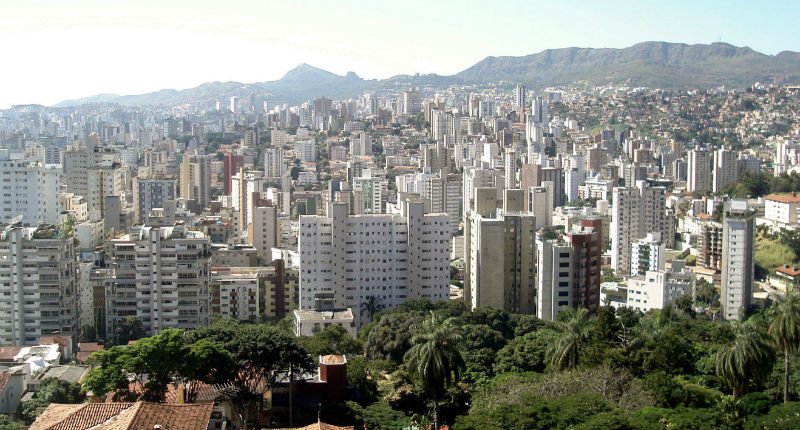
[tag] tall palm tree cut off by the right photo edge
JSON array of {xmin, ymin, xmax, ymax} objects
[{"xmin": 769, "ymin": 290, "xmax": 800, "ymax": 403}]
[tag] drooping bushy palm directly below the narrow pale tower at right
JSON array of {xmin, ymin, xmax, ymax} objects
[{"xmin": 716, "ymin": 318, "xmax": 775, "ymax": 398}]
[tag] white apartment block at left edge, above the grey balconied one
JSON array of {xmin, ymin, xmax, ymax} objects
[{"xmin": 0, "ymin": 151, "xmax": 62, "ymax": 225}]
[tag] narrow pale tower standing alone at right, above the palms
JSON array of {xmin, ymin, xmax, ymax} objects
[{"xmin": 720, "ymin": 200, "xmax": 756, "ymax": 320}]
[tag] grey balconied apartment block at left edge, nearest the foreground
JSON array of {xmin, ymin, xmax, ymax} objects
[{"xmin": 0, "ymin": 224, "xmax": 78, "ymax": 346}]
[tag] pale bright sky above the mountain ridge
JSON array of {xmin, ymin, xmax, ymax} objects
[{"xmin": 0, "ymin": 0, "xmax": 800, "ymax": 108}]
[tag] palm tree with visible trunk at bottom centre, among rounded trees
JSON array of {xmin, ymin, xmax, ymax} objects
[{"xmin": 403, "ymin": 311, "xmax": 464, "ymax": 430}]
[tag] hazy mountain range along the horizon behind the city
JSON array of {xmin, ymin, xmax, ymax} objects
[{"xmin": 56, "ymin": 42, "xmax": 800, "ymax": 107}]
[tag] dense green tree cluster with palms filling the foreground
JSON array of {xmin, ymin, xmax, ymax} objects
[{"xmin": 73, "ymin": 296, "xmax": 800, "ymax": 429}]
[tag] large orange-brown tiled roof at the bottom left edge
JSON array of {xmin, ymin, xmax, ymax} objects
[{"xmin": 29, "ymin": 402, "xmax": 214, "ymax": 430}]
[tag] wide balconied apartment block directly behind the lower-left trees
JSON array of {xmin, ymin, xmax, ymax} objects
[{"xmin": 106, "ymin": 225, "xmax": 211, "ymax": 336}]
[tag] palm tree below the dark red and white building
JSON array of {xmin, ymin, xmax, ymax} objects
[{"xmin": 547, "ymin": 308, "xmax": 590, "ymax": 370}]
